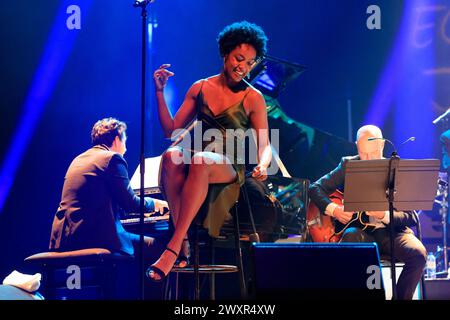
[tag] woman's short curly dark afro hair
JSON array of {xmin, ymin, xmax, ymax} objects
[{"xmin": 217, "ymin": 21, "xmax": 267, "ymax": 59}]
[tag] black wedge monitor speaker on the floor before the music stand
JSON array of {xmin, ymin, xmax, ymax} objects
[{"xmin": 251, "ymin": 243, "xmax": 385, "ymax": 300}]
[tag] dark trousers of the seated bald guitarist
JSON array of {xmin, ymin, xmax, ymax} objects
[{"xmin": 341, "ymin": 228, "xmax": 427, "ymax": 300}]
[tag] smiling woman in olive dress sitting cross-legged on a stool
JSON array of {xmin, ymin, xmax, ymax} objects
[{"xmin": 147, "ymin": 21, "xmax": 272, "ymax": 281}]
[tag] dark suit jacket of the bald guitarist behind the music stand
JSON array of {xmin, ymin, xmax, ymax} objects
[{"xmin": 308, "ymin": 156, "xmax": 418, "ymax": 231}]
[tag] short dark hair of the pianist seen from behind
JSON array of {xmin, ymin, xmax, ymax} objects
[{"xmin": 91, "ymin": 118, "xmax": 127, "ymax": 147}]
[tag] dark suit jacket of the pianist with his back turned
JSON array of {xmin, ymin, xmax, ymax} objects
[{"xmin": 50, "ymin": 145, "xmax": 154, "ymax": 254}]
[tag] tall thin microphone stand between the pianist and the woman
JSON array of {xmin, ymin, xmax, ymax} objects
[{"xmin": 133, "ymin": 0, "xmax": 152, "ymax": 300}]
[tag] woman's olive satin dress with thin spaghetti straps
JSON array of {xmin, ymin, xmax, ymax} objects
[{"xmin": 160, "ymin": 80, "xmax": 250, "ymax": 238}]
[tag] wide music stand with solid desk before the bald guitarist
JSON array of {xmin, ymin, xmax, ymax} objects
[{"xmin": 344, "ymin": 159, "xmax": 440, "ymax": 300}]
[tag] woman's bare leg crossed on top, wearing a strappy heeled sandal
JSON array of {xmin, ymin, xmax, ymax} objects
[{"xmin": 150, "ymin": 152, "xmax": 236, "ymax": 280}]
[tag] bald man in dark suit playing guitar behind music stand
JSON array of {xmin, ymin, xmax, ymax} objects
[{"xmin": 309, "ymin": 125, "xmax": 427, "ymax": 300}]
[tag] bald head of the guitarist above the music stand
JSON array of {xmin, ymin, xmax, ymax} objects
[{"xmin": 356, "ymin": 125, "xmax": 384, "ymax": 160}]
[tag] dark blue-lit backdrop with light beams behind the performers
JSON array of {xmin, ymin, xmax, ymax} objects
[{"xmin": 0, "ymin": 0, "xmax": 450, "ymax": 279}]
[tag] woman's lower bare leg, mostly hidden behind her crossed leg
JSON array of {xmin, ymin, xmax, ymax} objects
[{"xmin": 161, "ymin": 147, "xmax": 189, "ymax": 268}]
